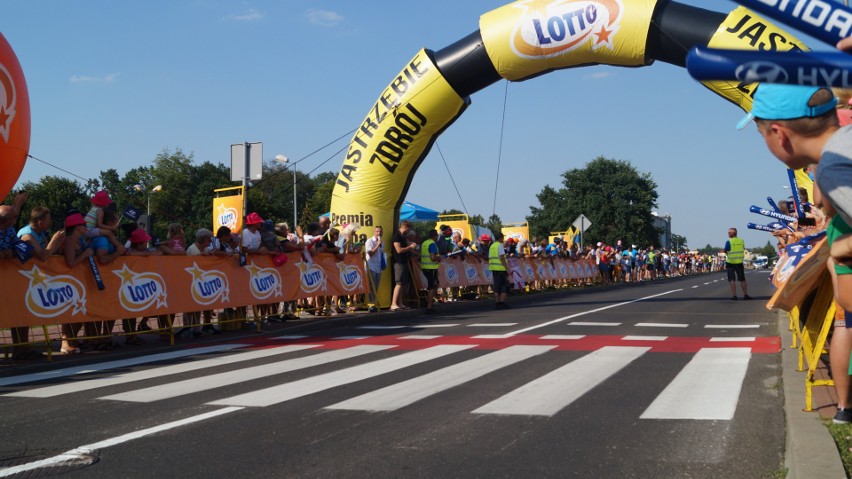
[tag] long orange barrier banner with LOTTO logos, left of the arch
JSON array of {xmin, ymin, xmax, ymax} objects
[{"xmin": 0, "ymin": 253, "xmax": 369, "ymax": 328}]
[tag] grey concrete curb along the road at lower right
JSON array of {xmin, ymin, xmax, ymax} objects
[{"xmin": 778, "ymin": 311, "xmax": 846, "ymax": 479}]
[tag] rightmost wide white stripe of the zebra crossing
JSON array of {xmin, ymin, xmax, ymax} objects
[{"xmin": 640, "ymin": 348, "xmax": 751, "ymax": 421}]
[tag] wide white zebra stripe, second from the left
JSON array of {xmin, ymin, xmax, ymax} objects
[{"xmin": 99, "ymin": 345, "xmax": 396, "ymax": 402}]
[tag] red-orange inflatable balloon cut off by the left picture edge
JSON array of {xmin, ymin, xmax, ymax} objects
[{"xmin": 0, "ymin": 33, "xmax": 30, "ymax": 201}]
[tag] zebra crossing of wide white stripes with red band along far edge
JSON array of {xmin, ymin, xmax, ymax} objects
[{"xmin": 0, "ymin": 335, "xmax": 772, "ymax": 420}]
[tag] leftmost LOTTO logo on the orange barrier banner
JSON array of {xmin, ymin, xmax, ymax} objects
[{"xmin": 19, "ymin": 266, "xmax": 86, "ymax": 318}]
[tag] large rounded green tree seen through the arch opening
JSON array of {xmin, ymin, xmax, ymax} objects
[{"xmin": 527, "ymin": 156, "xmax": 659, "ymax": 248}]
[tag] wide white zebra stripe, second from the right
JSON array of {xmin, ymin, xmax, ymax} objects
[{"xmin": 473, "ymin": 346, "xmax": 651, "ymax": 416}]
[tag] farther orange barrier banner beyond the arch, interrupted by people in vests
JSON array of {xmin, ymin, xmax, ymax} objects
[{"xmin": 411, "ymin": 256, "xmax": 600, "ymax": 290}]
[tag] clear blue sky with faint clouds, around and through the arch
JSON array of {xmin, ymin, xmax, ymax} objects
[{"xmin": 0, "ymin": 0, "xmax": 829, "ymax": 248}]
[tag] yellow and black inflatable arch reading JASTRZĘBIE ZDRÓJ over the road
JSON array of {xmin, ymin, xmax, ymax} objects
[{"xmin": 331, "ymin": 0, "xmax": 807, "ymax": 306}]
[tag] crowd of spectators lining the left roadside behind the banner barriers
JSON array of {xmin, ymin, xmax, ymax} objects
[{"xmin": 0, "ymin": 191, "xmax": 712, "ymax": 359}]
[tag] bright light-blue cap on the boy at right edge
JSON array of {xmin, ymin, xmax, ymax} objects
[{"xmin": 737, "ymin": 83, "xmax": 837, "ymax": 130}]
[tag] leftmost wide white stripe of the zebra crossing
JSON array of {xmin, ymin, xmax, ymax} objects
[{"xmin": 4, "ymin": 344, "xmax": 318, "ymax": 398}]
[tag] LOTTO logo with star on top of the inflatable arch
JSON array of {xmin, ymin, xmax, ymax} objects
[{"xmin": 512, "ymin": 0, "xmax": 624, "ymax": 59}]
